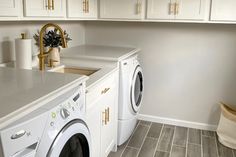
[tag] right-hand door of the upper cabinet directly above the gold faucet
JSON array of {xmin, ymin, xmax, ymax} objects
[{"xmin": 49, "ymin": 0, "xmax": 66, "ymax": 17}]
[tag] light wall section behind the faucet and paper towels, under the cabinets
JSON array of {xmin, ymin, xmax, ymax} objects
[{"xmin": 0, "ymin": 21, "xmax": 85, "ymax": 63}]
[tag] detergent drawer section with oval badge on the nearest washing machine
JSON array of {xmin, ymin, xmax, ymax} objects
[{"xmin": 0, "ymin": 109, "xmax": 48, "ymax": 157}]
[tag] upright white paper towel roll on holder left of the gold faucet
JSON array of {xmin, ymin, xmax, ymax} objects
[{"xmin": 15, "ymin": 39, "xmax": 32, "ymax": 69}]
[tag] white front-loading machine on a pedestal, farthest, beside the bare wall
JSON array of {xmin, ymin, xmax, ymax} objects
[{"xmin": 118, "ymin": 55, "xmax": 143, "ymax": 145}]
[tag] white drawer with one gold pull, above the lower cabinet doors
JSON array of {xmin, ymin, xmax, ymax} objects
[{"xmin": 86, "ymin": 74, "xmax": 117, "ymax": 109}]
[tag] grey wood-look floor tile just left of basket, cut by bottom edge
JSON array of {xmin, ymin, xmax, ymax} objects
[{"xmin": 202, "ymin": 136, "xmax": 217, "ymax": 157}]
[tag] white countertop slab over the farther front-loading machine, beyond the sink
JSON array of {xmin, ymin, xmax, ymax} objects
[{"xmin": 61, "ymin": 45, "xmax": 140, "ymax": 61}]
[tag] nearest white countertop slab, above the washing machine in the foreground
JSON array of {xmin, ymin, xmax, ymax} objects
[{"xmin": 0, "ymin": 67, "xmax": 88, "ymax": 126}]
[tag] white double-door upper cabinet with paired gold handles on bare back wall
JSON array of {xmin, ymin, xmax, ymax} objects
[{"xmin": 147, "ymin": 0, "xmax": 206, "ymax": 20}]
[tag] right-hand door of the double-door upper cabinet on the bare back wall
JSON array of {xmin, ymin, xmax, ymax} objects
[{"xmin": 175, "ymin": 0, "xmax": 206, "ymax": 20}]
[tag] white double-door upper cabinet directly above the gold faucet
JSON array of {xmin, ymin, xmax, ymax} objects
[{"xmin": 24, "ymin": 0, "xmax": 66, "ymax": 17}]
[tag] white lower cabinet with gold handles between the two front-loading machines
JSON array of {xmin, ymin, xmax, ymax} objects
[{"xmin": 86, "ymin": 71, "xmax": 118, "ymax": 157}]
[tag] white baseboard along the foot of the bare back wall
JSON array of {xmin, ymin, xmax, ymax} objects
[{"xmin": 138, "ymin": 114, "xmax": 217, "ymax": 131}]
